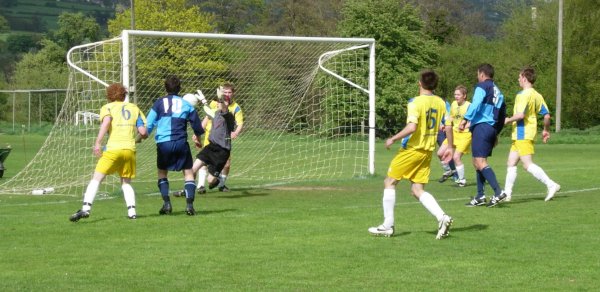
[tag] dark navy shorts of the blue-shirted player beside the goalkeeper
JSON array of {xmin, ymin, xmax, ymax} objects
[{"xmin": 156, "ymin": 140, "xmax": 194, "ymax": 171}]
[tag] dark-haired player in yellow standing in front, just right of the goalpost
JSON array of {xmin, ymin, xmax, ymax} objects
[{"xmin": 369, "ymin": 70, "xmax": 453, "ymax": 239}]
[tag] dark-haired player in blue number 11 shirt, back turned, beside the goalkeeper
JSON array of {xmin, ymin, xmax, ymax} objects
[{"xmin": 148, "ymin": 75, "xmax": 204, "ymax": 216}]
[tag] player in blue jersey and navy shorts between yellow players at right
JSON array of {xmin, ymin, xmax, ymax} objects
[{"xmin": 459, "ymin": 64, "xmax": 506, "ymax": 207}]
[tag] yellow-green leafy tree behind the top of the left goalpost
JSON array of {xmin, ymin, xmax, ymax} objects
[{"xmin": 108, "ymin": 0, "xmax": 220, "ymax": 92}]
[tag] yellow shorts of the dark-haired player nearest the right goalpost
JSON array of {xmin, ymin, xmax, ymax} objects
[{"xmin": 387, "ymin": 149, "xmax": 432, "ymax": 184}]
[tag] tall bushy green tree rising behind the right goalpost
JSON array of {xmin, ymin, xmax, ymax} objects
[{"xmin": 339, "ymin": 0, "xmax": 438, "ymax": 136}]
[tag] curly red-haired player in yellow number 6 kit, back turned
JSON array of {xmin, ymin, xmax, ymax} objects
[{"xmin": 69, "ymin": 83, "xmax": 148, "ymax": 222}]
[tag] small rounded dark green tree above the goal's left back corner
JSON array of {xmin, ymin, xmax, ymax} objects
[{"xmin": 54, "ymin": 12, "xmax": 101, "ymax": 50}]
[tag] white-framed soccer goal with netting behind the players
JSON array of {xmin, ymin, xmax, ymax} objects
[{"xmin": 0, "ymin": 30, "xmax": 375, "ymax": 193}]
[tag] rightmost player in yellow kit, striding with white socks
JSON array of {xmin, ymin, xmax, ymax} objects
[{"xmin": 504, "ymin": 68, "xmax": 560, "ymax": 201}]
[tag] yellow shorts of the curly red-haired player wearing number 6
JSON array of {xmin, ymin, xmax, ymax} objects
[{"xmin": 96, "ymin": 149, "xmax": 136, "ymax": 178}]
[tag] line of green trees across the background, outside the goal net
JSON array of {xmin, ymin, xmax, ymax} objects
[{"xmin": 0, "ymin": 0, "xmax": 600, "ymax": 132}]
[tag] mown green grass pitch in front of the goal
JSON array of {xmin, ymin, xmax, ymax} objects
[{"xmin": 0, "ymin": 136, "xmax": 600, "ymax": 291}]
